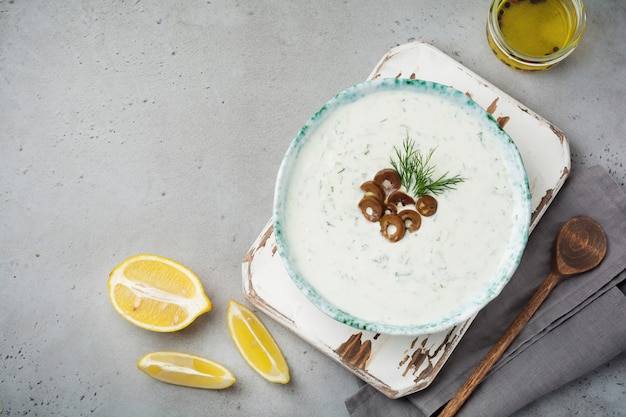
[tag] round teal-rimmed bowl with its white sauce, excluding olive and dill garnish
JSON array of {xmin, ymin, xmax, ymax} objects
[{"xmin": 273, "ymin": 79, "xmax": 531, "ymax": 335}]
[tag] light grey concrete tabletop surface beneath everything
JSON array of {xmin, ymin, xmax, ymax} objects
[{"xmin": 0, "ymin": 0, "xmax": 626, "ymax": 417}]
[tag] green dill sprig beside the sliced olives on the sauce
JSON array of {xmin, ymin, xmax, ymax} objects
[{"xmin": 391, "ymin": 135, "xmax": 465, "ymax": 197}]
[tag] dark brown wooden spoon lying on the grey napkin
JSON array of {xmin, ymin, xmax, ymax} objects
[{"xmin": 439, "ymin": 217, "xmax": 607, "ymax": 417}]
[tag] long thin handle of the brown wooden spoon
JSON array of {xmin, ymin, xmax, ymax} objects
[{"xmin": 438, "ymin": 271, "xmax": 562, "ymax": 417}]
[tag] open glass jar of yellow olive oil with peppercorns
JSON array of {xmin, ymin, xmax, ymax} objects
[{"xmin": 488, "ymin": 0, "xmax": 585, "ymax": 70}]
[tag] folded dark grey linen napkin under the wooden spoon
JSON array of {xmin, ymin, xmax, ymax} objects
[{"xmin": 345, "ymin": 167, "xmax": 626, "ymax": 417}]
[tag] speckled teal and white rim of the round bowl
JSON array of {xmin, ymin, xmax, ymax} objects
[{"xmin": 272, "ymin": 78, "xmax": 531, "ymax": 336}]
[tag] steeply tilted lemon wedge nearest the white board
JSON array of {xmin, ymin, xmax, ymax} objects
[{"xmin": 226, "ymin": 300, "xmax": 290, "ymax": 384}]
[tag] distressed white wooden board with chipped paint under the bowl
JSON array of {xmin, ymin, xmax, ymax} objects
[{"xmin": 242, "ymin": 42, "xmax": 570, "ymax": 398}]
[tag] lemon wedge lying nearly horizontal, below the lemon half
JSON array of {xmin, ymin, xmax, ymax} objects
[{"xmin": 137, "ymin": 351, "xmax": 236, "ymax": 389}]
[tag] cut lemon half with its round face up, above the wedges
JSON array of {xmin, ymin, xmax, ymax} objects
[{"xmin": 109, "ymin": 255, "xmax": 212, "ymax": 332}]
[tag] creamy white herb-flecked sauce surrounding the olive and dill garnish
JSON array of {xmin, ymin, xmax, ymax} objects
[{"xmin": 276, "ymin": 83, "xmax": 516, "ymax": 334}]
